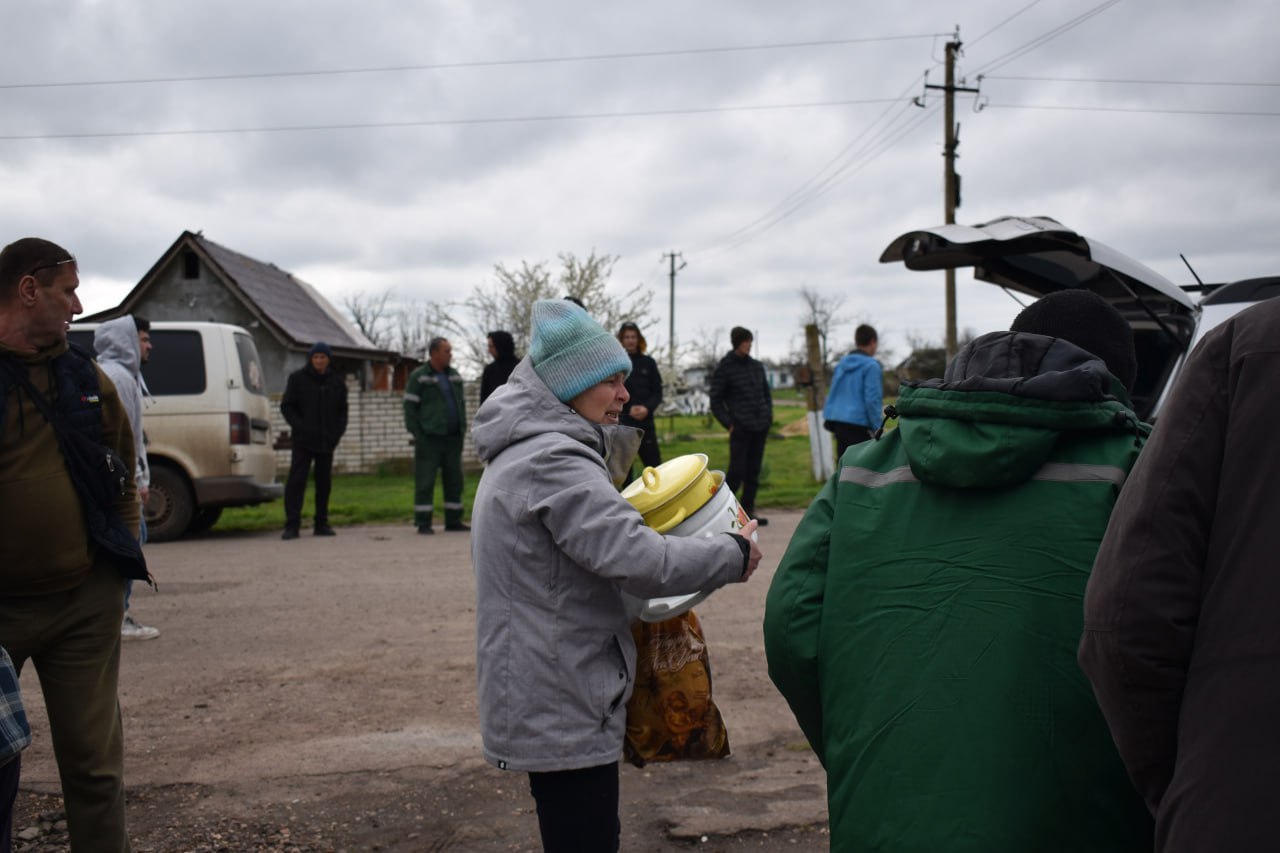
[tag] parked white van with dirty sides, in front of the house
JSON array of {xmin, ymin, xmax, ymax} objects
[{"xmin": 68, "ymin": 321, "xmax": 284, "ymax": 542}]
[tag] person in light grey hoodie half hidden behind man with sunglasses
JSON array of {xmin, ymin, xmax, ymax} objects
[{"xmin": 93, "ymin": 314, "xmax": 160, "ymax": 639}]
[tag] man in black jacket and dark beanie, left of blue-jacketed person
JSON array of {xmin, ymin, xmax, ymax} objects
[{"xmin": 710, "ymin": 325, "xmax": 773, "ymax": 526}]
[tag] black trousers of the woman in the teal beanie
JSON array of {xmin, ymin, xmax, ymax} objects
[{"xmin": 529, "ymin": 762, "xmax": 622, "ymax": 853}]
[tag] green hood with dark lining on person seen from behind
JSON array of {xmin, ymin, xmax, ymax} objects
[{"xmin": 897, "ymin": 332, "xmax": 1149, "ymax": 488}]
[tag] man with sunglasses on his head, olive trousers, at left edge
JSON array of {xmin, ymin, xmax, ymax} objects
[{"xmin": 0, "ymin": 237, "xmax": 148, "ymax": 850}]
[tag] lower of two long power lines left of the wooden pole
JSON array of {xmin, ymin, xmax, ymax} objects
[{"xmin": 0, "ymin": 97, "xmax": 897, "ymax": 142}]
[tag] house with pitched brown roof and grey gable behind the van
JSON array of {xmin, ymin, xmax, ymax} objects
[{"xmin": 83, "ymin": 231, "xmax": 399, "ymax": 396}]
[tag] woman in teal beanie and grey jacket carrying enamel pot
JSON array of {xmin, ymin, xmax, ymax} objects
[{"xmin": 471, "ymin": 300, "xmax": 760, "ymax": 850}]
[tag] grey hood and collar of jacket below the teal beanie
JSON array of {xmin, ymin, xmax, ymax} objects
[{"xmin": 471, "ymin": 356, "xmax": 643, "ymax": 482}]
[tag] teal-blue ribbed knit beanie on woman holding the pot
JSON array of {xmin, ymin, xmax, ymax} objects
[{"xmin": 529, "ymin": 300, "xmax": 631, "ymax": 402}]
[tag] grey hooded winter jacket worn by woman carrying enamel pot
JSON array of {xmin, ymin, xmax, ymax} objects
[{"xmin": 471, "ymin": 357, "xmax": 745, "ymax": 771}]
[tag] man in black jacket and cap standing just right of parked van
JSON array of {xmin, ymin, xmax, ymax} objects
[{"xmin": 280, "ymin": 341, "xmax": 347, "ymax": 539}]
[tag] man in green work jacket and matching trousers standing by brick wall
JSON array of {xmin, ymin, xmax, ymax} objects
[{"xmin": 404, "ymin": 338, "xmax": 470, "ymax": 534}]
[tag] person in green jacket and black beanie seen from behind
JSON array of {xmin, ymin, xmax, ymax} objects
[{"xmin": 764, "ymin": 289, "xmax": 1153, "ymax": 853}]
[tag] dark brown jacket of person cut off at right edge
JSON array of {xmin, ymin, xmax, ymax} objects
[{"xmin": 1079, "ymin": 294, "xmax": 1280, "ymax": 853}]
